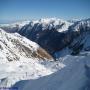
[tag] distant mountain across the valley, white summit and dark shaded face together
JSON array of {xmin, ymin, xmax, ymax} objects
[{"xmin": 0, "ymin": 19, "xmax": 90, "ymax": 57}]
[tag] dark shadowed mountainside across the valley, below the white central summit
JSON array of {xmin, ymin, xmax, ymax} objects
[{"xmin": 18, "ymin": 19, "xmax": 90, "ymax": 56}]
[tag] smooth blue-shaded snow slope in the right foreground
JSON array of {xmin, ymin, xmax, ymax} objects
[{"xmin": 14, "ymin": 53, "xmax": 90, "ymax": 90}]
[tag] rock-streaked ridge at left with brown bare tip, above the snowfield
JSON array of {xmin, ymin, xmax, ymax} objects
[{"xmin": 0, "ymin": 29, "xmax": 53, "ymax": 62}]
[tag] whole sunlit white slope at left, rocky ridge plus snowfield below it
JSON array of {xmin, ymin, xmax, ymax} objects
[{"xmin": 0, "ymin": 29, "xmax": 64, "ymax": 87}]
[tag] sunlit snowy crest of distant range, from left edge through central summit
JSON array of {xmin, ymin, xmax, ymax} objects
[{"xmin": 0, "ymin": 18, "xmax": 72, "ymax": 32}]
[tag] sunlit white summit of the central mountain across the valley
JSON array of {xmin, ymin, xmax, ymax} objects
[{"xmin": 26, "ymin": 18, "xmax": 72, "ymax": 32}]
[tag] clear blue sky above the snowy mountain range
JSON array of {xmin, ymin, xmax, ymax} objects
[{"xmin": 0, "ymin": 0, "xmax": 90, "ymax": 21}]
